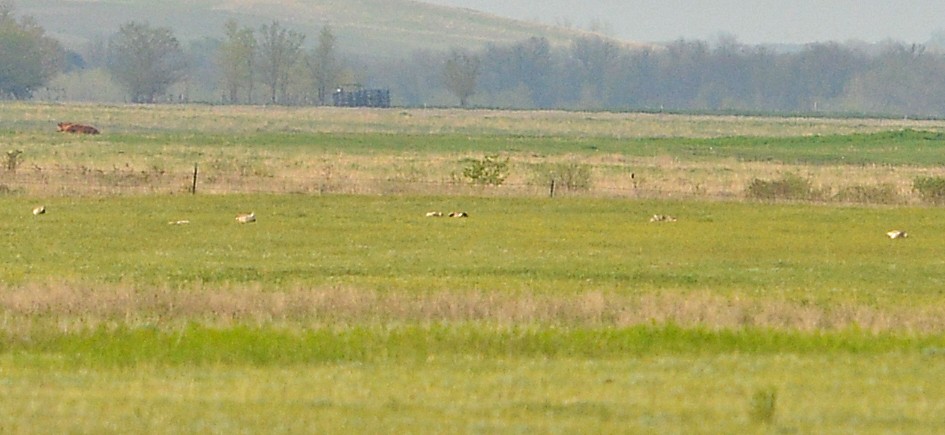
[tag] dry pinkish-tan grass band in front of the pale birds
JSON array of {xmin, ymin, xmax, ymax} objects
[{"xmin": 7, "ymin": 283, "xmax": 945, "ymax": 335}]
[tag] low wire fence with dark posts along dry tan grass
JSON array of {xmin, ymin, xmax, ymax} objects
[{"xmin": 7, "ymin": 164, "xmax": 928, "ymax": 205}]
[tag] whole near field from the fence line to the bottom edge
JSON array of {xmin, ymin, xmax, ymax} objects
[{"xmin": 0, "ymin": 195, "xmax": 945, "ymax": 433}]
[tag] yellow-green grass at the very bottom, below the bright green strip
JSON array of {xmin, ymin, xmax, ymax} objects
[{"xmin": 0, "ymin": 353, "xmax": 945, "ymax": 433}]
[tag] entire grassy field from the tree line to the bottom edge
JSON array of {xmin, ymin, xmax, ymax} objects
[{"xmin": 0, "ymin": 104, "xmax": 945, "ymax": 433}]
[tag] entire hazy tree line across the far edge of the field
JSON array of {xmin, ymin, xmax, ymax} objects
[{"xmin": 0, "ymin": 2, "xmax": 945, "ymax": 117}]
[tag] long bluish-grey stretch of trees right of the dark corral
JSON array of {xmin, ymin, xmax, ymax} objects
[{"xmin": 380, "ymin": 35, "xmax": 945, "ymax": 117}]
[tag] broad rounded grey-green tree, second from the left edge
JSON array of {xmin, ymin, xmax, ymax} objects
[{"xmin": 108, "ymin": 22, "xmax": 187, "ymax": 103}]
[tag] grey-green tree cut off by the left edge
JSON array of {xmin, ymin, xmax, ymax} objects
[{"xmin": 0, "ymin": 1, "xmax": 64, "ymax": 99}]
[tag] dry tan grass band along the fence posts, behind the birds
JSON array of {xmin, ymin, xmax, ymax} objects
[{"xmin": 7, "ymin": 147, "xmax": 945, "ymax": 204}]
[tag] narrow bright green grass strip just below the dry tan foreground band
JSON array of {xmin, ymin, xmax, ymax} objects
[{"xmin": 7, "ymin": 323, "xmax": 945, "ymax": 367}]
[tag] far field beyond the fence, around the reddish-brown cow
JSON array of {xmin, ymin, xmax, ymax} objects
[{"xmin": 0, "ymin": 103, "xmax": 945, "ymax": 201}]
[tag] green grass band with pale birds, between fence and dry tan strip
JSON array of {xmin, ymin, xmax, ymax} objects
[{"xmin": 0, "ymin": 195, "xmax": 945, "ymax": 305}]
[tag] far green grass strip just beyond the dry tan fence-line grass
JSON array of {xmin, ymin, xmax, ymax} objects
[{"xmin": 6, "ymin": 130, "xmax": 945, "ymax": 166}]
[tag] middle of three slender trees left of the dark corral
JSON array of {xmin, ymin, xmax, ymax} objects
[{"xmin": 259, "ymin": 21, "xmax": 305, "ymax": 104}]
